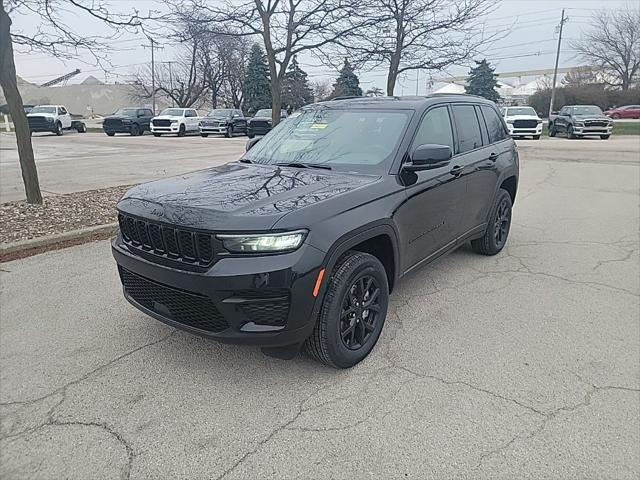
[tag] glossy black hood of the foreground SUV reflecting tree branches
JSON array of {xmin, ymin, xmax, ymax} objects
[{"xmin": 118, "ymin": 162, "xmax": 380, "ymax": 231}]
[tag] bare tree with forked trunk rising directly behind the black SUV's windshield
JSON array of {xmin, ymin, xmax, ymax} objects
[{"xmin": 175, "ymin": 0, "xmax": 361, "ymax": 125}]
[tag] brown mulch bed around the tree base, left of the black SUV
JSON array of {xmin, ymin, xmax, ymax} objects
[{"xmin": 0, "ymin": 185, "xmax": 131, "ymax": 243}]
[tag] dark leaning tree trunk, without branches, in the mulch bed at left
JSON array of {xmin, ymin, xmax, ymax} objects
[{"xmin": 0, "ymin": 4, "xmax": 42, "ymax": 204}]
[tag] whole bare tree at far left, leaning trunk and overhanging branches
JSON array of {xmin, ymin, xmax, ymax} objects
[{"xmin": 0, "ymin": 0, "xmax": 159, "ymax": 204}]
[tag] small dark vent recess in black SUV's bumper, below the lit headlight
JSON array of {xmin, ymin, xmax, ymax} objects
[{"xmin": 234, "ymin": 289, "xmax": 291, "ymax": 326}]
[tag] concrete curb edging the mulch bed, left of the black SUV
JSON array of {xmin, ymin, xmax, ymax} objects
[{"xmin": 0, "ymin": 222, "xmax": 118, "ymax": 262}]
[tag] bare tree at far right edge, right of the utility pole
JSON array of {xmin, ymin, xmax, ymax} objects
[{"xmin": 571, "ymin": 6, "xmax": 640, "ymax": 90}]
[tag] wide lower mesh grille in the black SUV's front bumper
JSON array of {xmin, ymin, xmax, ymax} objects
[{"xmin": 119, "ymin": 267, "xmax": 229, "ymax": 332}]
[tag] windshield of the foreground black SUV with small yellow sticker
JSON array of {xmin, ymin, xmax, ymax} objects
[{"xmin": 243, "ymin": 108, "xmax": 412, "ymax": 172}]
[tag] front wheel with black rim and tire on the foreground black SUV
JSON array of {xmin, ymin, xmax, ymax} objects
[{"xmin": 305, "ymin": 251, "xmax": 389, "ymax": 368}]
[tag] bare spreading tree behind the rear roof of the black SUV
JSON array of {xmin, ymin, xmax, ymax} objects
[{"xmin": 333, "ymin": 0, "xmax": 497, "ymax": 96}]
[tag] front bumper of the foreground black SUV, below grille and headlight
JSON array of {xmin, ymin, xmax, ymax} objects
[{"xmin": 112, "ymin": 234, "xmax": 325, "ymax": 347}]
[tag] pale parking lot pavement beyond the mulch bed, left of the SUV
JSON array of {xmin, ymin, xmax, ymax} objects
[{"xmin": 0, "ymin": 132, "xmax": 248, "ymax": 202}]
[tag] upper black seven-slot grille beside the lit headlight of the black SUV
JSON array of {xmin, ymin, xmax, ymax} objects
[{"xmin": 118, "ymin": 213, "xmax": 214, "ymax": 266}]
